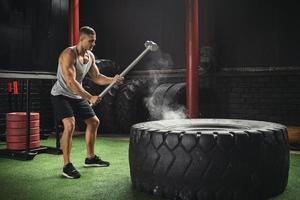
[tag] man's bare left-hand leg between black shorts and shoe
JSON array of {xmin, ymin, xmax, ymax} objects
[{"xmin": 60, "ymin": 117, "xmax": 75, "ymax": 165}]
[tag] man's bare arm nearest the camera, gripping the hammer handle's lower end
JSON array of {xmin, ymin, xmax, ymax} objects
[{"xmin": 59, "ymin": 48, "xmax": 100, "ymax": 104}]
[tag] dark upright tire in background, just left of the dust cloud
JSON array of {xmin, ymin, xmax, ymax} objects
[{"xmin": 116, "ymin": 79, "xmax": 149, "ymax": 135}]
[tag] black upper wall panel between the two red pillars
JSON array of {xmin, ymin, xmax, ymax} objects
[{"xmin": 80, "ymin": 0, "xmax": 185, "ymax": 69}]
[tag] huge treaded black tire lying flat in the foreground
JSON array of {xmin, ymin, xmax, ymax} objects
[{"xmin": 129, "ymin": 119, "xmax": 289, "ymax": 200}]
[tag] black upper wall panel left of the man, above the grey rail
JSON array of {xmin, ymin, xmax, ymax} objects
[{"xmin": 0, "ymin": 0, "xmax": 69, "ymax": 71}]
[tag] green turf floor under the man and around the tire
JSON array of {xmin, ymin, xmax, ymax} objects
[{"xmin": 0, "ymin": 136, "xmax": 300, "ymax": 200}]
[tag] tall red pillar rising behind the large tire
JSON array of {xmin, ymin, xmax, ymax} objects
[{"xmin": 186, "ymin": 0, "xmax": 200, "ymax": 118}]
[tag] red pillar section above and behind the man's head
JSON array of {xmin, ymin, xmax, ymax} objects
[{"xmin": 69, "ymin": 0, "xmax": 79, "ymax": 46}]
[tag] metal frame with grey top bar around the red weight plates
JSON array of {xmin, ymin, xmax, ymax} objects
[{"xmin": 0, "ymin": 71, "xmax": 62, "ymax": 160}]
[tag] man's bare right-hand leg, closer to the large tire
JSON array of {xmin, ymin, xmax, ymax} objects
[{"xmin": 85, "ymin": 116, "xmax": 99, "ymax": 158}]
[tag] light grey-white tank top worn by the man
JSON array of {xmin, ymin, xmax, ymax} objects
[{"xmin": 51, "ymin": 46, "xmax": 92, "ymax": 99}]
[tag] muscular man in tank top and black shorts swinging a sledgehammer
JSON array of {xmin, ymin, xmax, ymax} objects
[{"xmin": 51, "ymin": 26, "xmax": 123, "ymax": 178}]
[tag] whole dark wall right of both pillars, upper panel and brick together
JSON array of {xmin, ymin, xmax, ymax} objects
[{"xmin": 199, "ymin": 0, "xmax": 300, "ymax": 126}]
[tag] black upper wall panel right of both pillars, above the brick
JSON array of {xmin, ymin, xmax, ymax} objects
[{"xmin": 209, "ymin": 0, "xmax": 300, "ymax": 67}]
